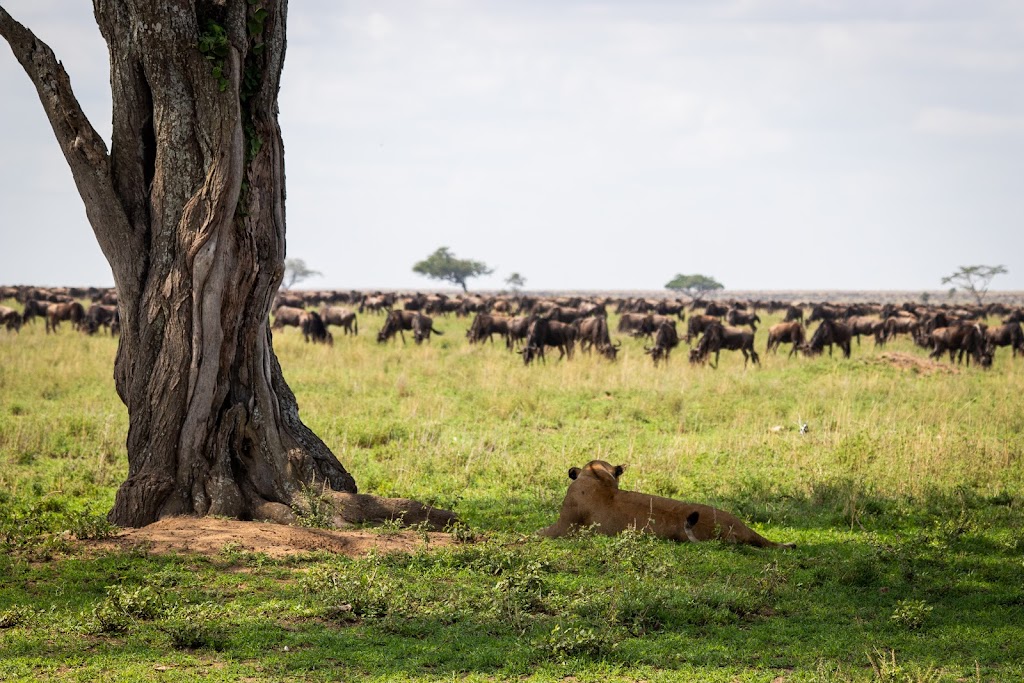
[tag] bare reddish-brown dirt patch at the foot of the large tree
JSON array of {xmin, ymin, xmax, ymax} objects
[{"xmin": 81, "ymin": 517, "xmax": 453, "ymax": 558}]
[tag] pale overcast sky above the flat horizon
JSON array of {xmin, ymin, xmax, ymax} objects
[{"xmin": 0, "ymin": 0, "xmax": 1024, "ymax": 291}]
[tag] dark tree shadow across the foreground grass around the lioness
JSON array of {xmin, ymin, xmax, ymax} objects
[{"xmin": 0, "ymin": 487, "xmax": 1024, "ymax": 680}]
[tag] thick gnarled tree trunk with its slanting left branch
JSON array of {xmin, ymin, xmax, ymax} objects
[{"xmin": 0, "ymin": 0, "xmax": 355, "ymax": 526}]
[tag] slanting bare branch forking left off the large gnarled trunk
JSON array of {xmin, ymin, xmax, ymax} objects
[{"xmin": 0, "ymin": 7, "xmax": 145, "ymax": 287}]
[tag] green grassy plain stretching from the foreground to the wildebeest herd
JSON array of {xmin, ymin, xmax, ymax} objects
[{"xmin": 0, "ymin": 302, "xmax": 1024, "ymax": 681}]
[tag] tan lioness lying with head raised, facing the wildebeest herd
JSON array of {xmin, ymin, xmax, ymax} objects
[{"xmin": 538, "ymin": 460, "xmax": 795, "ymax": 548}]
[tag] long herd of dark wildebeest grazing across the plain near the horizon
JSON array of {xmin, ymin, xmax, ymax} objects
[{"xmin": 0, "ymin": 287, "xmax": 1024, "ymax": 368}]
